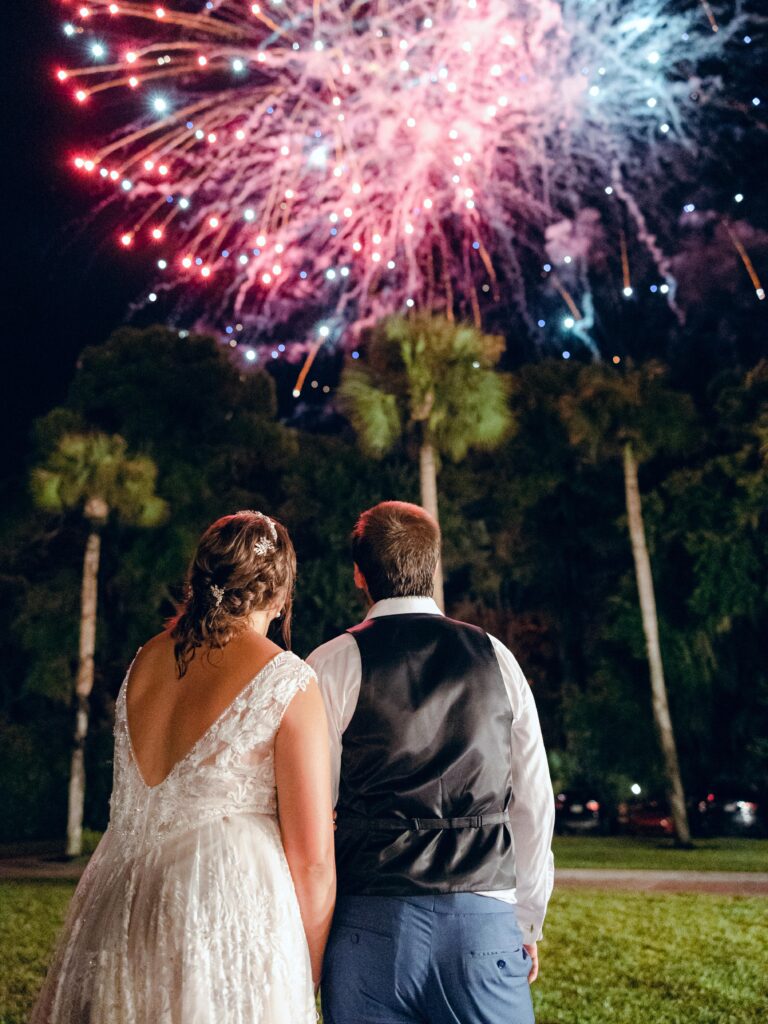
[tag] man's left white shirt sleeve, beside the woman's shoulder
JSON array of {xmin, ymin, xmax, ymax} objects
[{"xmin": 306, "ymin": 633, "xmax": 362, "ymax": 807}]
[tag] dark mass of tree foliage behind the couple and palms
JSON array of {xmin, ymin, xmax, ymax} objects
[{"xmin": 0, "ymin": 328, "xmax": 768, "ymax": 840}]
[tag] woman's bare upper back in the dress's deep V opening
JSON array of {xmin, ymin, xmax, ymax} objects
[{"xmin": 126, "ymin": 630, "xmax": 281, "ymax": 786}]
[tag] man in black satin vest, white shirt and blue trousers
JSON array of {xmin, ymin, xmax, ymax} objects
[{"xmin": 308, "ymin": 502, "xmax": 554, "ymax": 1024}]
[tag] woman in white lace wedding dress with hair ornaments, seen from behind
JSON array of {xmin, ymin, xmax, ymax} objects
[{"xmin": 31, "ymin": 511, "xmax": 336, "ymax": 1024}]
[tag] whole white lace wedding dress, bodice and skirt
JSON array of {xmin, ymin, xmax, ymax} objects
[{"xmin": 31, "ymin": 651, "xmax": 316, "ymax": 1024}]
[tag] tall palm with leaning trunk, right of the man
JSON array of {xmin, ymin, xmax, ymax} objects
[{"xmin": 561, "ymin": 362, "xmax": 693, "ymax": 846}]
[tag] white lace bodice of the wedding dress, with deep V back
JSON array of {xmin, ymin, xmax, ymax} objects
[{"xmin": 110, "ymin": 651, "xmax": 312, "ymax": 854}]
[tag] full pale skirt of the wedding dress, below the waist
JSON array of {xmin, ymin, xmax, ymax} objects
[{"xmin": 31, "ymin": 814, "xmax": 316, "ymax": 1024}]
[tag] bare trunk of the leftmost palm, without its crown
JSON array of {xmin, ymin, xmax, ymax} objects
[{"xmin": 67, "ymin": 529, "xmax": 101, "ymax": 857}]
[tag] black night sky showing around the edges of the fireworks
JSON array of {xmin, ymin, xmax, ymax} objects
[{"xmin": 6, "ymin": 0, "xmax": 768, "ymax": 483}]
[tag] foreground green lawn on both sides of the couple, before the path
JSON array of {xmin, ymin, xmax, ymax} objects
[{"xmin": 0, "ymin": 882, "xmax": 768, "ymax": 1024}]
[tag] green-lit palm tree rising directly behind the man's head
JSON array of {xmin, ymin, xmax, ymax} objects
[{"xmin": 339, "ymin": 313, "xmax": 511, "ymax": 607}]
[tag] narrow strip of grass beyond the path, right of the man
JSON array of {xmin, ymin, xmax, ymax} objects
[{"xmin": 553, "ymin": 836, "xmax": 768, "ymax": 871}]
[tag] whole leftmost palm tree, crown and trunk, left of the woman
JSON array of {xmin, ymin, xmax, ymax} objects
[{"xmin": 32, "ymin": 432, "xmax": 167, "ymax": 857}]
